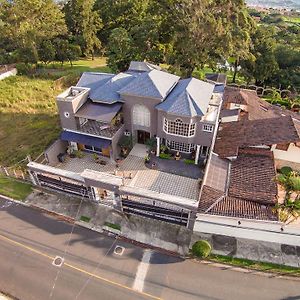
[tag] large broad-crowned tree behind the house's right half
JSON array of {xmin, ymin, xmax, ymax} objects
[{"xmin": 170, "ymin": 0, "xmax": 252, "ymax": 77}]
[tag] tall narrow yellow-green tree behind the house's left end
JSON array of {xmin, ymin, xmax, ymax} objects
[{"xmin": 63, "ymin": 0, "xmax": 102, "ymax": 59}]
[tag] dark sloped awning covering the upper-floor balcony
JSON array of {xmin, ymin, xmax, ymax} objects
[{"xmin": 75, "ymin": 101, "xmax": 122, "ymax": 123}]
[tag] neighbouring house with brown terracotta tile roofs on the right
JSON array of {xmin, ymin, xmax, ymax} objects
[{"xmin": 199, "ymin": 87, "xmax": 300, "ymax": 221}]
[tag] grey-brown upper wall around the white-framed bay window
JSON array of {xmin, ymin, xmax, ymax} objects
[{"xmin": 157, "ymin": 111, "xmax": 215, "ymax": 146}]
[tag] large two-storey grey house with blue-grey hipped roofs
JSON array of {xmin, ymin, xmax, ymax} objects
[{"xmin": 57, "ymin": 62, "xmax": 221, "ymax": 163}]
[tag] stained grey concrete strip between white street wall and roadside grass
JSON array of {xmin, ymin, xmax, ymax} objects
[{"xmin": 190, "ymin": 233, "xmax": 300, "ymax": 267}]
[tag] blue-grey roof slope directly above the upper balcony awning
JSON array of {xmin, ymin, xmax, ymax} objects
[{"xmin": 90, "ymin": 73, "xmax": 138, "ymax": 103}]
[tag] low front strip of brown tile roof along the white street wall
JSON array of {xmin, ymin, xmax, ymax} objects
[{"xmin": 199, "ymin": 186, "xmax": 278, "ymax": 221}]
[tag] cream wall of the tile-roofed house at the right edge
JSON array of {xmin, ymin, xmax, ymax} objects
[{"xmin": 271, "ymin": 144, "xmax": 300, "ymax": 169}]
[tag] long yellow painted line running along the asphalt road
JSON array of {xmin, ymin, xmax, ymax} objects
[{"xmin": 0, "ymin": 234, "xmax": 162, "ymax": 300}]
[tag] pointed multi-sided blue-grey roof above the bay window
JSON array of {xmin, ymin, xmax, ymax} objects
[{"xmin": 156, "ymin": 78, "xmax": 214, "ymax": 117}]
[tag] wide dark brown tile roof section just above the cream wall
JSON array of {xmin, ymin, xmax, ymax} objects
[{"xmin": 214, "ymin": 116, "xmax": 300, "ymax": 157}]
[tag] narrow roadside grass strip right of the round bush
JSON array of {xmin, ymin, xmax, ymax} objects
[{"xmin": 208, "ymin": 255, "xmax": 300, "ymax": 276}]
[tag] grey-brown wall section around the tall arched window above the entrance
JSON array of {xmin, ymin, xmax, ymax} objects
[{"xmin": 122, "ymin": 95, "xmax": 161, "ymax": 137}]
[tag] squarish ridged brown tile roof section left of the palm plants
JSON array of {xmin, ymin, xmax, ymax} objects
[{"xmin": 228, "ymin": 149, "xmax": 277, "ymax": 204}]
